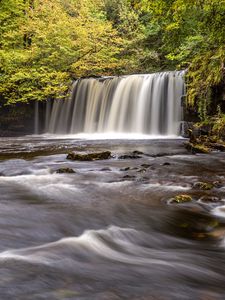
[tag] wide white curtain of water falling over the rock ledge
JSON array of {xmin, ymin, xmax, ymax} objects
[{"xmin": 45, "ymin": 71, "xmax": 184, "ymax": 136}]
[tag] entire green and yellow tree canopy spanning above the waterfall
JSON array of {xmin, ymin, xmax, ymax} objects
[{"xmin": 0, "ymin": 0, "xmax": 225, "ymax": 119}]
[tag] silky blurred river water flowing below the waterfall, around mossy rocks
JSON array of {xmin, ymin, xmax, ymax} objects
[{"xmin": 0, "ymin": 136, "xmax": 225, "ymax": 300}]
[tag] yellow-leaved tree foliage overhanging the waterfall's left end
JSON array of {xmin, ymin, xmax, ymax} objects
[{"xmin": 0, "ymin": 0, "xmax": 123, "ymax": 103}]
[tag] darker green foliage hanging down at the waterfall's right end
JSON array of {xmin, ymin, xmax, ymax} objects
[{"xmin": 139, "ymin": 0, "xmax": 225, "ymax": 119}]
